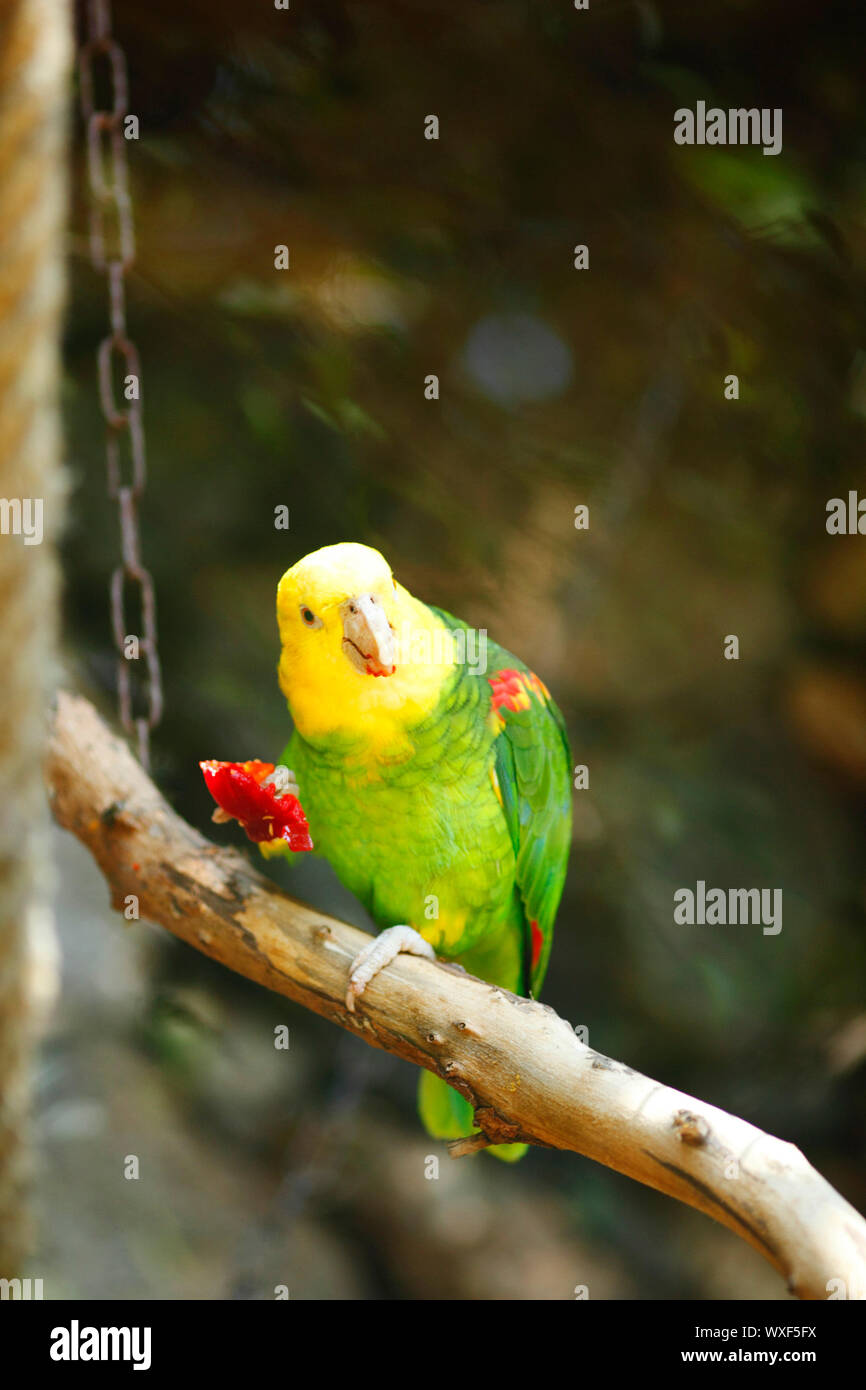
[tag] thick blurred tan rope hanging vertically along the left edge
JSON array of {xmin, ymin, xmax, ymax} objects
[{"xmin": 0, "ymin": 0, "xmax": 71, "ymax": 1279}]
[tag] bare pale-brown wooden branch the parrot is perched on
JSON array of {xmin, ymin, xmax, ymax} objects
[{"xmin": 47, "ymin": 695, "xmax": 866, "ymax": 1298}]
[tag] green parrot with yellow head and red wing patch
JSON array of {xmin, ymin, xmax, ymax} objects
[{"xmin": 260, "ymin": 542, "xmax": 571, "ymax": 1162}]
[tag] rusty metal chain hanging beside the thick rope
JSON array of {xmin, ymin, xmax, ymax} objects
[{"xmin": 78, "ymin": 0, "xmax": 163, "ymax": 769}]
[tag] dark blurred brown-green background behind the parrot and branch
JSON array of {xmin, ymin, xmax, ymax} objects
[{"xmin": 38, "ymin": 0, "xmax": 866, "ymax": 1298}]
